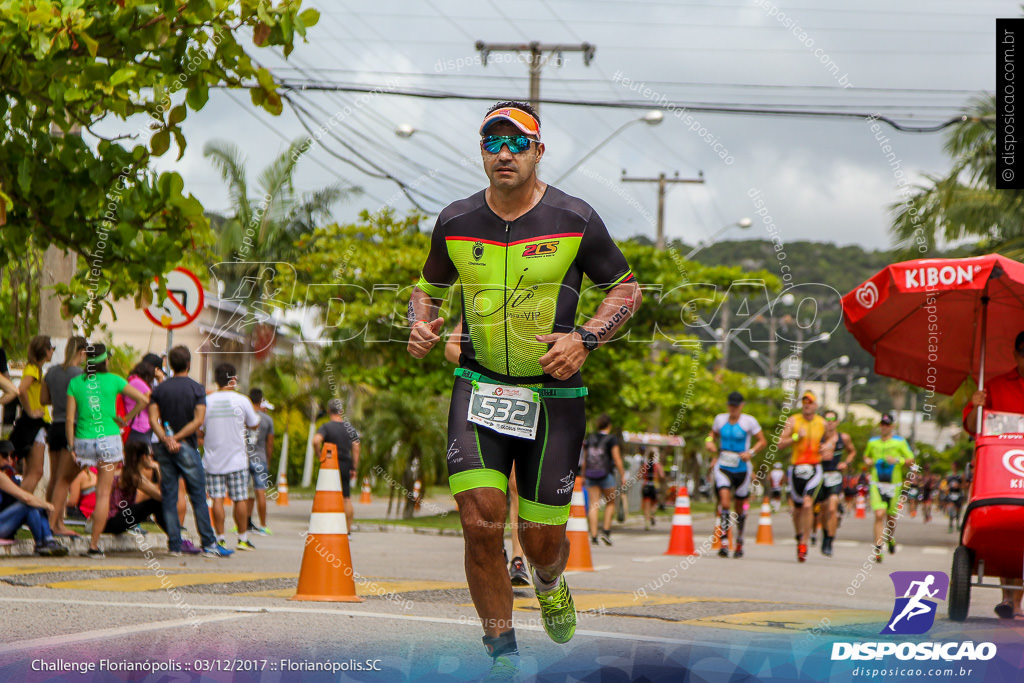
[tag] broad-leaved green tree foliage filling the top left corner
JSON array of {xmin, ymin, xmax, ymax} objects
[{"xmin": 0, "ymin": 0, "xmax": 318, "ymax": 328}]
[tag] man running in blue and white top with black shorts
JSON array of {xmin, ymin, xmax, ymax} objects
[{"xmin": 705, "ymin": 391, "xmax": 768, "ymax": 557}]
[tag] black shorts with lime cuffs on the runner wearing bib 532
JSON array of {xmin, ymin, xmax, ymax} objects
[{"xmin": 447, "ymin": 374, "xmax": 587, "ymax": 525}]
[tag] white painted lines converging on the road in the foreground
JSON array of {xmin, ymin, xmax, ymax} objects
[{"xmin": 0, "ymin": 597, "xmax": 770, "ymax": 653}]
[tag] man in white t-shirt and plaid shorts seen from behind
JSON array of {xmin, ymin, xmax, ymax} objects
[{"xmin": 201, "ymin": 362, "xmax": 260, "ymax": 550}]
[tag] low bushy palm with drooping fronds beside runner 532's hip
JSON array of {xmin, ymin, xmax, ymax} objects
[{"xmin": 358, "ymin": 391, "xmax": 447, "ymax": 519}]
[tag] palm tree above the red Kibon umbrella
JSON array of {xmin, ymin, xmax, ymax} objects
[{"xmin": 890, "ymin": 95, "xmax": 1024, "ymax": 259}]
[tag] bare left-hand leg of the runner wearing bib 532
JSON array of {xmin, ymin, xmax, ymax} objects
[{"xmin": 456, "ymin": 488, "xmax": 516, "ymax": 637}]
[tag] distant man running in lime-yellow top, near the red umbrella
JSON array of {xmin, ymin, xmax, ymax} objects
[{"xmin": 864, "ymin": 413, "xmax": 913, "ymax": 562}]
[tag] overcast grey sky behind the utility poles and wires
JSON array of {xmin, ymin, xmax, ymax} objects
[{"xmin": 125, "ymin": 0, "xmax": 1007, "ymax": 254}]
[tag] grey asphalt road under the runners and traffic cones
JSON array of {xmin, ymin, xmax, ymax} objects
[{"xmin": 0, "ymin": 500, "xmax": 1024, "ymax": 681}]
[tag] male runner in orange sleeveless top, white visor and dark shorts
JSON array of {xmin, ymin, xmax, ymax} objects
[{"xmin": 778, "ymin": 391, "xmax": 825, "ymax": 562}]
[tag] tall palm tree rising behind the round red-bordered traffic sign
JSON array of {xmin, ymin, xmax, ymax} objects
[{"xmin": 203, "ymin": 138, "xmax": 361, "ymax": 296}]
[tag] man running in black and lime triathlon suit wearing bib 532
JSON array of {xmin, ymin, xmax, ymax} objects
[{"xmin": 409, "ymin": 102, "xmax": 641, "ymax": 680}]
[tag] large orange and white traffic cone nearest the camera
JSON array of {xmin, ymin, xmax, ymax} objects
[{"xmin": 290, "ymin": 443, "xmax": 362, "ymax": 602}]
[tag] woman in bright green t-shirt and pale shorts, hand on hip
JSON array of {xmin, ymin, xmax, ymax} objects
[{"xmin": 65, "ymin": 344, "xmax": 150, "ymax": 559}]
